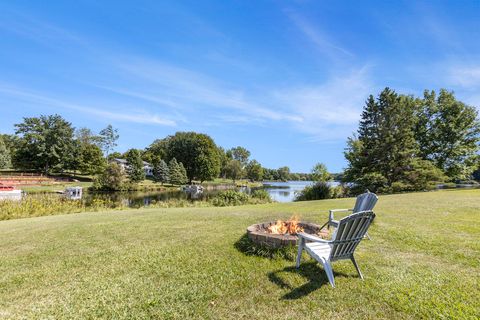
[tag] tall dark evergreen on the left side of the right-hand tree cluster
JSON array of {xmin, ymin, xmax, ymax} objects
[{"xmin": 343, "ymin": 88, "xmax": 452, "ymax": 193}]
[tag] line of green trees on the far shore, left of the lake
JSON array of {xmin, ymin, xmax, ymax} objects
[{"xmin": 0, "ymin": 114, "xmax": 310, "ymax": 185}]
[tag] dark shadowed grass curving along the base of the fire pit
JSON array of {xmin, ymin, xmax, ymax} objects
[{"xmin": 234, "ymin": 234, "xmax": 297, "ymax": 261}]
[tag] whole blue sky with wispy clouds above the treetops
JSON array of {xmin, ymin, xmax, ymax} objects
[{"xmin": 0, "ymin": 0, "xmax": 480, "ymax": 172}]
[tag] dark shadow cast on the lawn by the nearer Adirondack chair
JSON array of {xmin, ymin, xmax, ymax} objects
[{"xmin": 268, "ymin": 261, "xmax": 349, "ymax": 300}]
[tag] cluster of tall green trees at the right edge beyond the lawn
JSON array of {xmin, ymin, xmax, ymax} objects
[{"xmin": 342, "ymin": 88, "xmax": 480, "ymax": 193}]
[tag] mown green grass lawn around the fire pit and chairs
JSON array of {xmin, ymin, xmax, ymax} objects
[{"xmin": 0, "ymin": 190, "xmax": 480, "ymax": 319}]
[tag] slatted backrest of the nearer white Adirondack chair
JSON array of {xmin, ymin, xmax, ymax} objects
[{"xmin": 330, "ymin": 210, "xmax": 375, "ymax": 261}]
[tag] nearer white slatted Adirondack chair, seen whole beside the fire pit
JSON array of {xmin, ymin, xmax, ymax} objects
[{"xmin": 297, "ymin": 211, "xmax": 375, "ymax": 288}]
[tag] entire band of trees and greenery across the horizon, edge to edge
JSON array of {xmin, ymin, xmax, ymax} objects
[{"xmin": 0, "ymin": 88, "xmax": 480, "ymax": 210}]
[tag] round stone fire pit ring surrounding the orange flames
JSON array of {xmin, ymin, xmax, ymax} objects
[{"xmin": 247, "ymin": 221, "xmax": 328, "ymax": 248}]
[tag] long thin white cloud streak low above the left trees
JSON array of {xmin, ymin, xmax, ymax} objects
[{"xmin": 0, "ymin": 86, "xmax": 176, "ymax": 126}]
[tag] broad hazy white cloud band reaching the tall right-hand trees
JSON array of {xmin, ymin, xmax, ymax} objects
[{"xmin": 92, "ymin": 58, "xmax": 375, "ymax": 141}]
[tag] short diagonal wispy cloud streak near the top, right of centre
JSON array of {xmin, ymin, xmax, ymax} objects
[{"xmin": 285, "ymin": 10, "xmax": 354, "ymax": 59}]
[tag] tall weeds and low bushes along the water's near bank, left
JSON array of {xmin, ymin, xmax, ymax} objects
[{"xmin": 0, "ymin": 190, "xmax": 272, "ymax": 220}]
